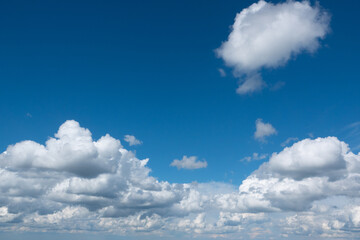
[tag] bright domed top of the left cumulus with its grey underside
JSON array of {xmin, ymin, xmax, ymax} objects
[{"xmin": 0, "ymin": 121, "xmax": 121, "ymax": 177}]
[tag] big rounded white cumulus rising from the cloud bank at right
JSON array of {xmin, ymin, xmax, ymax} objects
[{"xmin": 216, "ymin": 137, "xmax": 360, "ymax": 216}]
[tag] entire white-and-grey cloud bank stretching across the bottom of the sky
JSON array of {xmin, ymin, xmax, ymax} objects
[{"xmin": 0, "ymin": 120, "xmax": 360, "ymax": 239}]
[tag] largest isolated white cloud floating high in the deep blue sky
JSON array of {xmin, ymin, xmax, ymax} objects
[{"xmin": 217, "ymin": 0, "xmax": 330, "ymax": 94}]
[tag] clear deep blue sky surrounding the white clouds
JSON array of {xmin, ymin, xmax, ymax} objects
[{"xmin": 0, "ymin": 0, "xmax": 360, "ymax": 239}]
